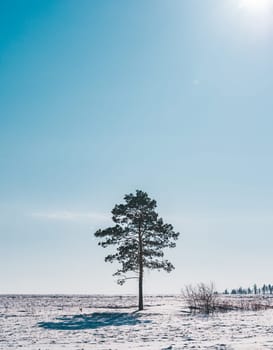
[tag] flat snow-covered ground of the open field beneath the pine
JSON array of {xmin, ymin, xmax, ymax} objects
[{"xmin": 0, "ymin": 295, "xmax": 273, "ymax": 350}]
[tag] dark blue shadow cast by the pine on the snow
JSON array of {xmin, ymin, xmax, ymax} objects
[{"xmin": 38, "ymin": 312, "xmax": 150, "ymax": 330}]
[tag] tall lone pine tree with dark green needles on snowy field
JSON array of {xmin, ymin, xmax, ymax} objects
[{"xmin": 95, "ymin": 190, "xmax": 179, "ymax": 310}]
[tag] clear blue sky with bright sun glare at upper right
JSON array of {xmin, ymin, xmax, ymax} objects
[{"xmin": 0, "ymin": 0, "xmax": 273, "ymax": 293}]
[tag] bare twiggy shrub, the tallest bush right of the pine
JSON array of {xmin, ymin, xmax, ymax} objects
[{"xmin": 182, "ymin": 283, "xmax": 218, "ymax": 314}]
